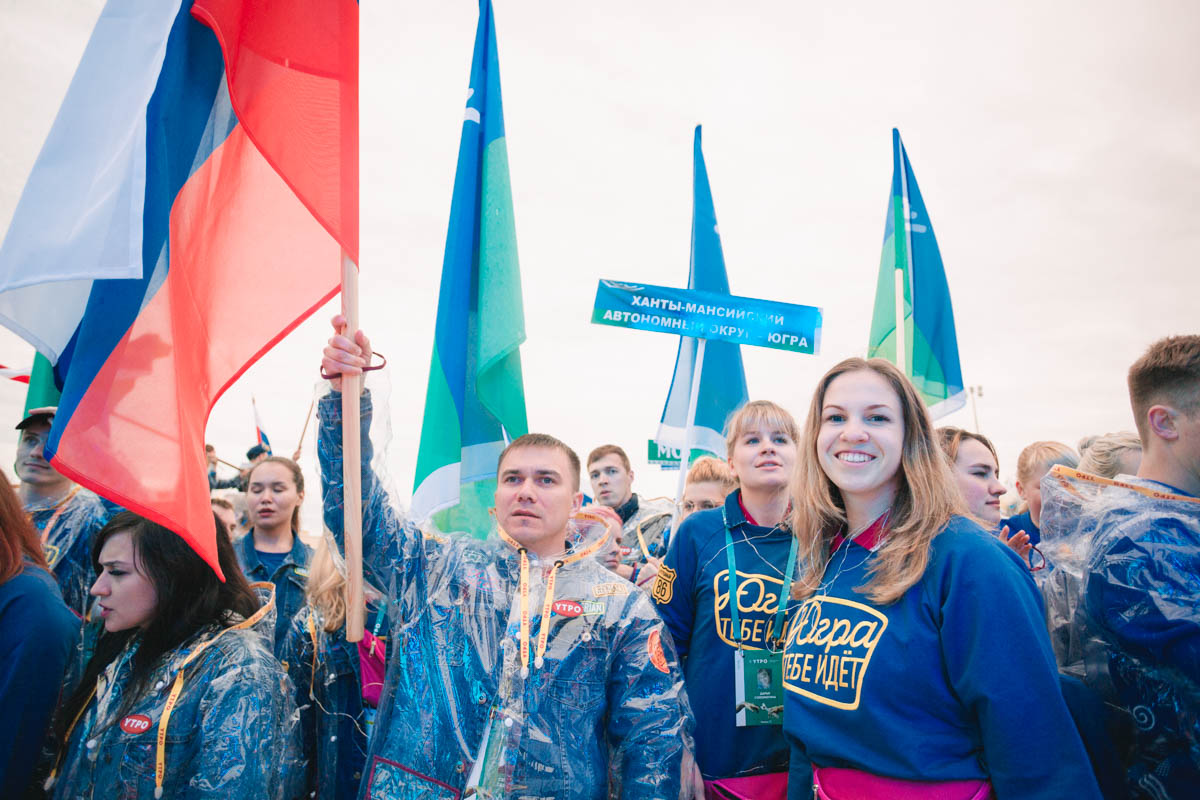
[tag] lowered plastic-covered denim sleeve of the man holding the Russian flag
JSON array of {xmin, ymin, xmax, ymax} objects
[{"xmin": 608, "ymin": 594, "xmax": 695, "ymax": 800}]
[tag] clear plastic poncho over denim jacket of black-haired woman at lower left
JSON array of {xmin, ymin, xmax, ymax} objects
[{"xmin": 48, "ymin": 584, "xmax": 305, "ymax": 800}]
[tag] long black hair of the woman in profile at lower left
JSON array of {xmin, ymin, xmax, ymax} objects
[{"xmin": 52, "ymin": 511, "xmax": 260, "ymax": 750}]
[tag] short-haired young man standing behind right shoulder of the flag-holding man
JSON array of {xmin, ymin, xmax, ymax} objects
[{"xmin": 588, "ymin": 445, "xmax": 676, "ymax": 584}]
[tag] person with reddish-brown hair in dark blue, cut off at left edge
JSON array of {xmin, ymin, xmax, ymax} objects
[{"xmin": 0, "ymin": 471, "xmax": 79, "ymax": 798}]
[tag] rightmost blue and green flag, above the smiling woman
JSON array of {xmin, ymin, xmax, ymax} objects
[{"xmin": 866, "ymin": 128, "xmax": 966, "ymax": 419}]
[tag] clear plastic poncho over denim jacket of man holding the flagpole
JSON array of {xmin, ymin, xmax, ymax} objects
[{"xmin": 318, "ymin": 383, "xmax": 692, "ymax": 800}]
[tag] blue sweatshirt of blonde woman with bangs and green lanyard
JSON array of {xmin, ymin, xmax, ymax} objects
[{"xmin": 653, "ymin": 491, "xmax": 792, "ymax": 780}]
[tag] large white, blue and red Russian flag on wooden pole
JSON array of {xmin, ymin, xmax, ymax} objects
[{"xmin": 0, "ymin": 0, "xmax": 359, "ymax": 573}]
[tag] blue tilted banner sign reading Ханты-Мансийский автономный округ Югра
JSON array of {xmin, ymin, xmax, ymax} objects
[{"xmin": 592, "ymin": 281, "xmax": 821, "ymax": 355}]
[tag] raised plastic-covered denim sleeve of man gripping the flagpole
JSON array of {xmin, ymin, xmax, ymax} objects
[{"xmin": 317, "ymin": 391, "xmax": 425, "ymax": 603}]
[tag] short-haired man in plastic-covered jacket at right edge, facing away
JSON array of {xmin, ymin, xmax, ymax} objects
[{"xmin": 1070, "ymin": 336, "xmax": 1200, "ymax": 800}]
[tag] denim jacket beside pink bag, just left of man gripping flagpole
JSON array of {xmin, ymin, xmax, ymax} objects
[{"xmin": 280, "ymin": 606, "xmax": 373, "ymax": 800}]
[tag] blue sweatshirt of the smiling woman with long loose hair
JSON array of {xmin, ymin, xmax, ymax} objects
[{"xmin": 784, "ymin": 517, "xmax": 1100, "ymax": 800}]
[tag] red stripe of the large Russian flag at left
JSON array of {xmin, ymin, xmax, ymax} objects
[{"xmin": 54, "ymin": 0, "xmax": 359, "ymax": 575}]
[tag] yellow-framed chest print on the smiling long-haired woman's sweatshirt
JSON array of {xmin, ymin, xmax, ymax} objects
[{"xmin": 784, "ymin": 596, "xmax": 888, "ymax": 711}]
